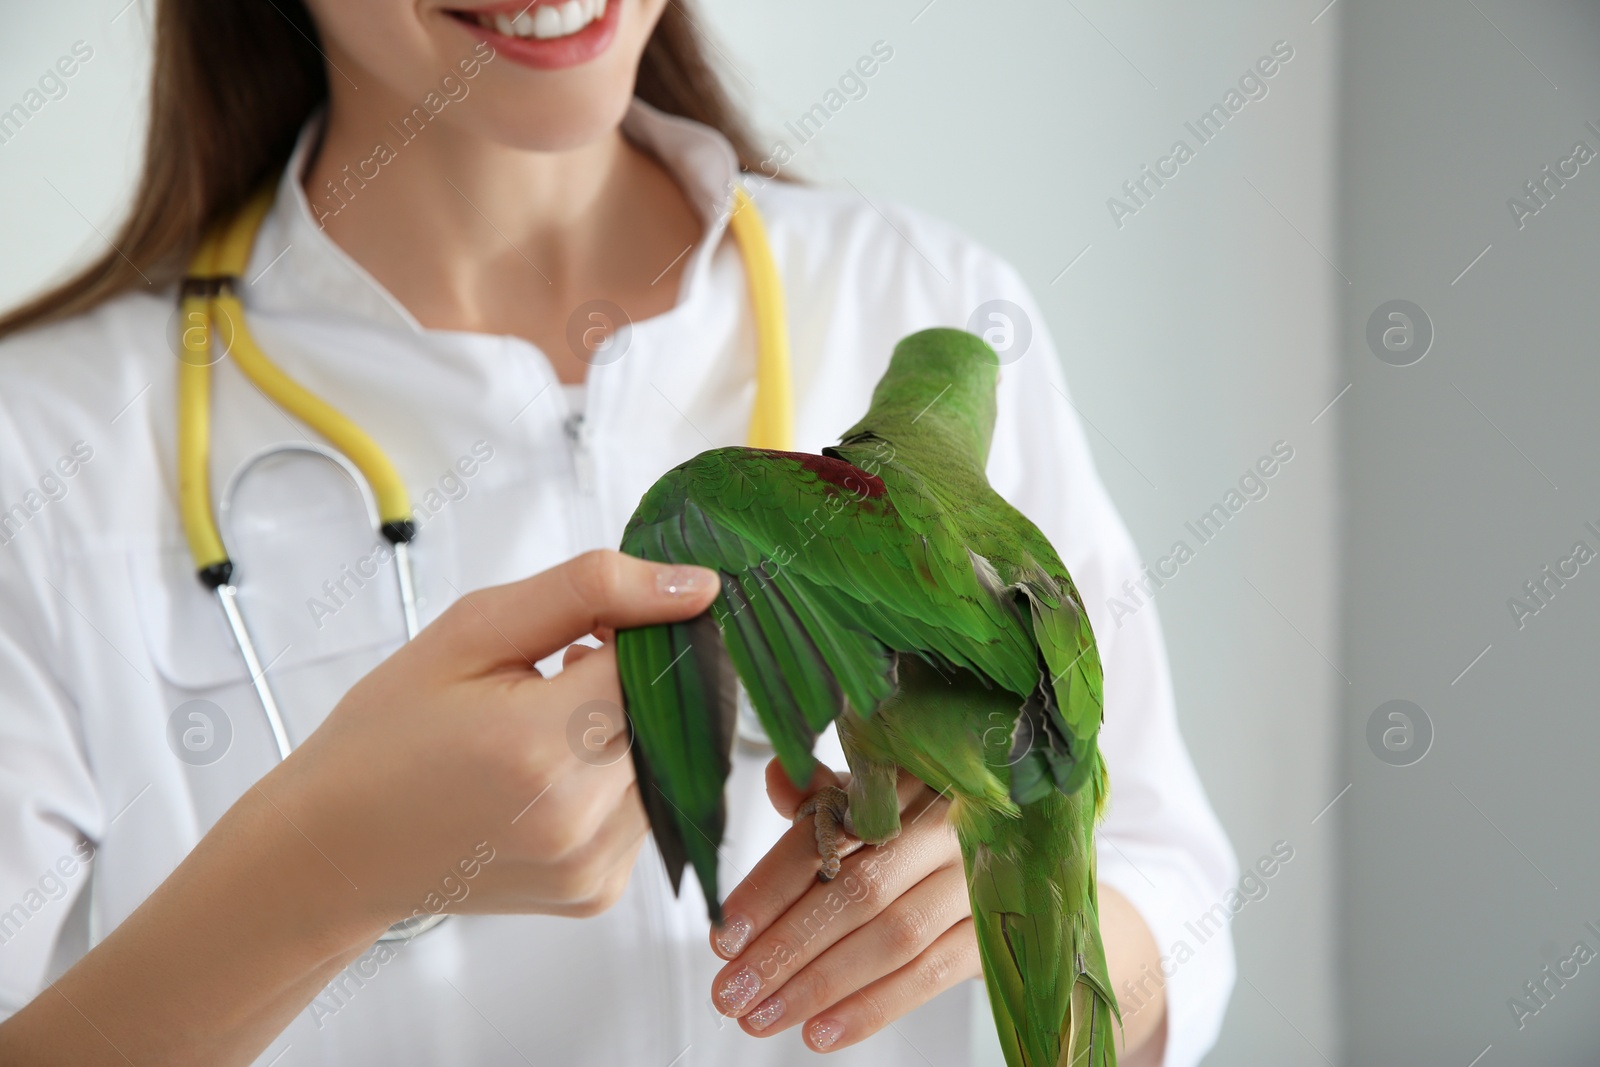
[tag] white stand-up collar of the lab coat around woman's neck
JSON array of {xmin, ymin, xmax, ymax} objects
[{"xmin": 245, "ymin": 96, "xmax": 739, "ymax": 334}]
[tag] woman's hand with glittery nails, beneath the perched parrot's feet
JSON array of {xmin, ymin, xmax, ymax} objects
[{"xmin": 712, "ymin": 760, "xmax": 981, "ymax": 1053}]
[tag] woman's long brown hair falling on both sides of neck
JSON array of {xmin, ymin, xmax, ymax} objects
[{"xmin": 0, "ymin": 0, "xmax": 774, "ymax": 338}]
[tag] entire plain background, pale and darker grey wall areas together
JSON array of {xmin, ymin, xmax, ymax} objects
[{"xmin": 0, "ymin": 0, "xmax": 1600, "ymax": 1067}]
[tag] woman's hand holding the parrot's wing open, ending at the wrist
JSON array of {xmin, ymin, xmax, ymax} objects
[{"xmin": 280, "ymin": 552, "xmax": 717, "ymax": 926}]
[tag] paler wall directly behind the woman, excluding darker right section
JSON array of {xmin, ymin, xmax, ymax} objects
[{"xmin": 0, "ymin": 0, "xmax": 1347, "ymax": 1065}]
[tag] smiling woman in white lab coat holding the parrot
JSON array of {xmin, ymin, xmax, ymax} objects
[{"xmin": 0, "ymin": 0, "xmax": 1235, "ymax": 1067}]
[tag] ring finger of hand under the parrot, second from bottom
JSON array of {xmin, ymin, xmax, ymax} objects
[{"xmin": 741, "ymin": 867, "xmax": 971, "ymax": 1033}]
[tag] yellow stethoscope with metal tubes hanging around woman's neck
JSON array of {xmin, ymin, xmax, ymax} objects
[{"xmin": 178, "ymin": 182, "xmax": 794, "ymax": 941}]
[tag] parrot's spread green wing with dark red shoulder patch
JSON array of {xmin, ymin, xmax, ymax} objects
[{"xmin": 618, "ymin": 446, "xmax": 1049, "ymax": 918}]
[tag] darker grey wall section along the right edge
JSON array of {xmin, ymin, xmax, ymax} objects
[{"xmin": 1341, "ymin": 0, "xmax": 1600, "ymax": 1067}]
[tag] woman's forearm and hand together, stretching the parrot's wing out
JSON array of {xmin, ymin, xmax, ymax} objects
[{"xmin": 0, "ymin": 552, "xmax": 717, "ymax": 1067}]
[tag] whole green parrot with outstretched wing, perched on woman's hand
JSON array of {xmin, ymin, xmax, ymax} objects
[{"xmin": 616, "ymin": 330, "xmax": 1122, "ymax": 1067}]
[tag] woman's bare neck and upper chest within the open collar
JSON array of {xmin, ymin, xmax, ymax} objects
[{"xmin": 304, "ymin": 65, "xmax": 701, "ymax": 381}]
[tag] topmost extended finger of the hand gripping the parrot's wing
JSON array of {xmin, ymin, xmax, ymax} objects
[{"xmin": 427, "ymin": 550, "xmax": 718, "ymax": 673}]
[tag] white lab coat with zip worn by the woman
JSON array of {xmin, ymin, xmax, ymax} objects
[{"xmin": 0, "ymin": 102, "xmax": 1237, "ymax": 1067}]
